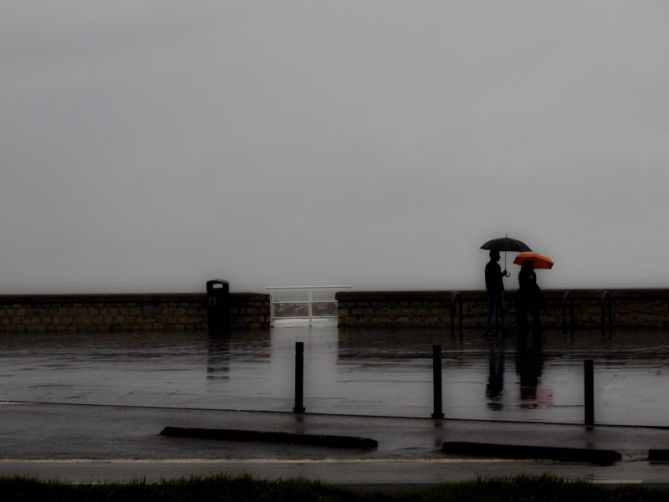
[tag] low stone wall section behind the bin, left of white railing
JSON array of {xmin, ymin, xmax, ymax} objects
[{"xmin": 0, "ymin": 293, "xmax": 270, "ymax": 333}]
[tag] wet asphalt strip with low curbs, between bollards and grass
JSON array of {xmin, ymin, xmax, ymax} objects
[{"xmin": 0, "ymin": 402, "xmax": 669, "ymax": 487}]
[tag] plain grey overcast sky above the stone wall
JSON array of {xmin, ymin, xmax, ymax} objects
[{"xmin": 0, "ymin": 0, "xmax": 669, "ymax": 293}]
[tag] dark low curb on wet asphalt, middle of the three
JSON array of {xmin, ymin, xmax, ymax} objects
[{"xmin": 441, "ymin": 441, "xmax": 622, "ymax": 465}]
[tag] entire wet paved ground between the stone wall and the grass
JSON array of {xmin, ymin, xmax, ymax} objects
[{"xmin": 0, "ymin": 325, "xmax": 669, "ymax": 487}]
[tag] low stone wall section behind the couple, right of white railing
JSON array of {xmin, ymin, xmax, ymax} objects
[{"xmin": 336, "ymin": 289, "xmax": 669, "ymax": 329}]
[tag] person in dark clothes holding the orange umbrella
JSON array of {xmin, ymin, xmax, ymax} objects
[{"xmin": 513, "ymin": 253, "xmax": 553, "ymax": 334}]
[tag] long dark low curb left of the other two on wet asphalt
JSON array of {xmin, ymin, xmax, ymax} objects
[{"xmin": 160, "ymin": 427, "xmax": 379, "ymax": 450}]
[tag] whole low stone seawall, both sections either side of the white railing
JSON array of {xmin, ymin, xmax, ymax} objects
[{"xmin": 0, "ymin": 289, "xmax": 669, "ymax": 333}]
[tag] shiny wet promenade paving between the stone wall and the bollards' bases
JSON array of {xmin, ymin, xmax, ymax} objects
[{"xmin": 0, "ymin": 325, "xmax": 669, "ymax": 426}]
